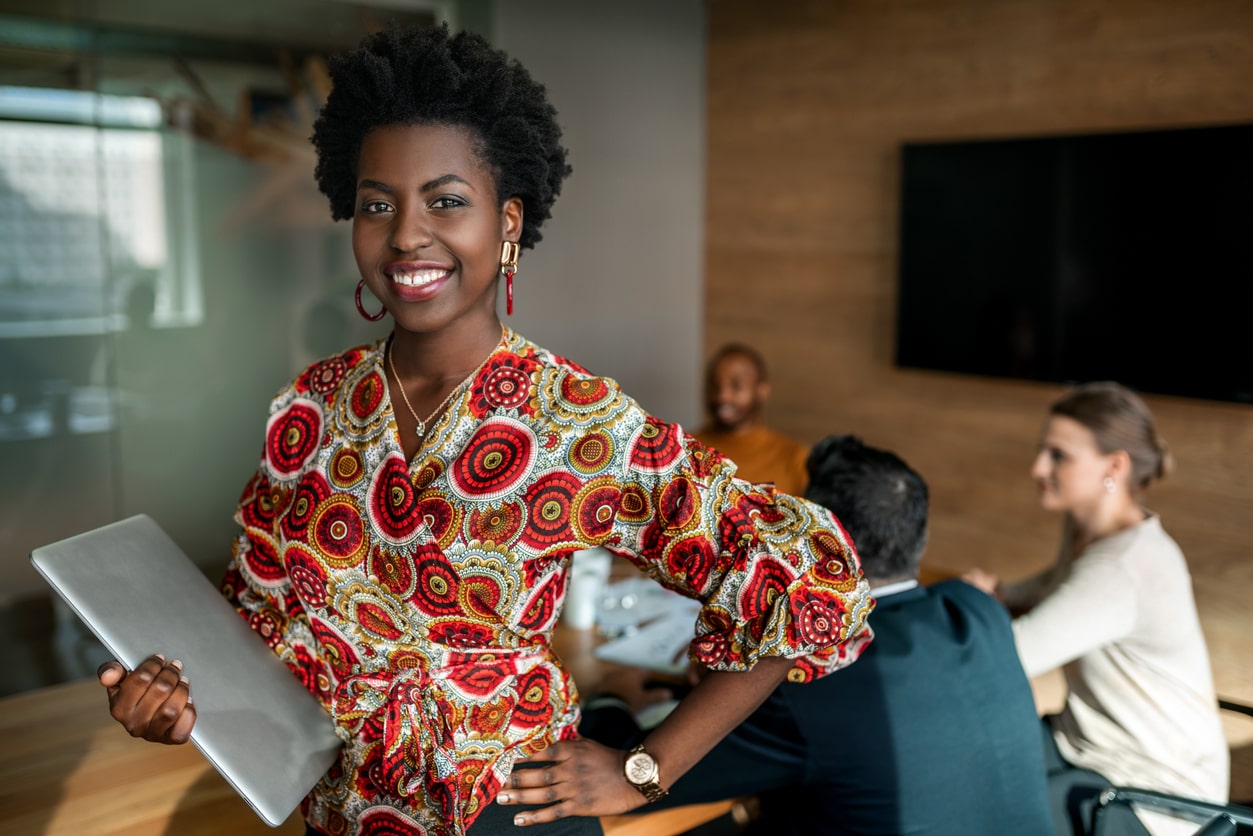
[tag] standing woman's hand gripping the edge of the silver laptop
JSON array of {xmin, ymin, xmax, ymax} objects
[{"xmin": 96, "ymin": 654, "xmax": 195, "ymax": 745}]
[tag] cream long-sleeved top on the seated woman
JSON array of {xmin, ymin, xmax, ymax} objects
[{"xmin": 1014, "ymin": 514, "xmax": 1229, "ymax": 832}]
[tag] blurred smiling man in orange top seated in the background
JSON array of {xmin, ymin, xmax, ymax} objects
[{"xmin": 694, "ymin": 342, "xmax": 808, "ymax": 496}]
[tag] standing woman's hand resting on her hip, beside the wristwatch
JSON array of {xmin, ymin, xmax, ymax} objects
[{"xmin": 496, "ymin": 738, "xmax": 645, "ymax": 825}]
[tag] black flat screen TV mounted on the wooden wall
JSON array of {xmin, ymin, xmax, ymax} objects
[{"xmin": 896, "ymin": 124, "xmax": 1253, "ymax": 404}]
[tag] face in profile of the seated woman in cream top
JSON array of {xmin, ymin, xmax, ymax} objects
[{"xmin": 1031, "ymin": 415, "xmax": 1113, "ymax": 511}]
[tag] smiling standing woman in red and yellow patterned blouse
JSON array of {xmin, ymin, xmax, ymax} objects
[{"xmin": 90, "ymin": 22, "xmax": 872, "ymax": 836}]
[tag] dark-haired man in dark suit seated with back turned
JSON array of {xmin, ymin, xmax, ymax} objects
[{"xmin": 580, "ymin": 436, "xmax": 1053, "ymax": 836}]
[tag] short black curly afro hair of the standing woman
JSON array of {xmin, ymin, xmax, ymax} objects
[{"xmin": 312, "ymin": 24, "xmax": 570, "ymax": 247}]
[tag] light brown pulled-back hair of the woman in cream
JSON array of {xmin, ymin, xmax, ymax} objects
[{"xmin": 1049, "ymin": 382, "xmax": 1173, "ymax": 490}]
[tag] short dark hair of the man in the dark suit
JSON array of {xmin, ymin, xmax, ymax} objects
[{"xmin": 804, "ymin": 435, "xmax": 927, "ymax": 580}]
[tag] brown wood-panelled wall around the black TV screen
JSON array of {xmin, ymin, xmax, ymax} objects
[{"xmin": 705, "ymin": 0, "xmax": 1253, "ymax": 703}]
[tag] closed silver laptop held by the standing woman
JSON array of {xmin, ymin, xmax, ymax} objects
[{"xmin": 30, "ymin": 514, "xmax": 341, "ymax": 827}]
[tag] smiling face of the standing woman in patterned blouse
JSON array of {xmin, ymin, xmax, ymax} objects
[{"xmin": 352, "ymin": 124, "xmax": 523, "ymax": 333}]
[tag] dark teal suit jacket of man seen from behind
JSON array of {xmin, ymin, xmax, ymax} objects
[{"xmin": 675, "ymin": 582, "xmax": 1053, "ymax": 836}]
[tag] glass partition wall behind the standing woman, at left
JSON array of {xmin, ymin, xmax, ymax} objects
[{"xmin": 0, "ymin": 0, "xmax": 435, "ymax": 696}]
